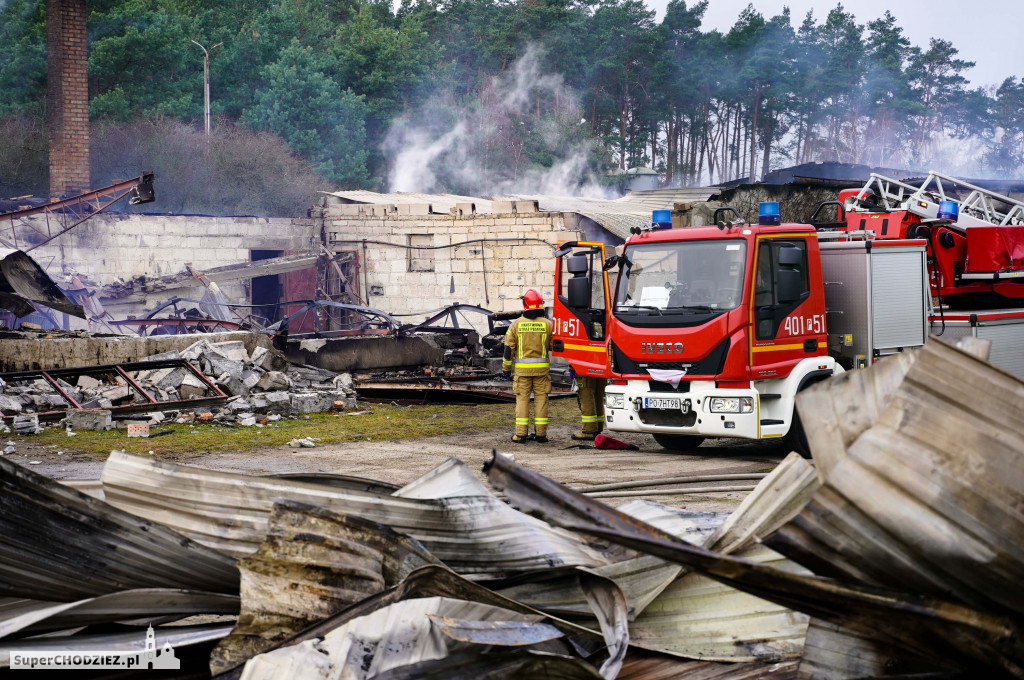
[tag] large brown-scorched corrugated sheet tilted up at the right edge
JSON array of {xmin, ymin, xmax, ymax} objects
[{"xmin": 772, "ymin": 338, "xmax": 1024, "ymax": 614}]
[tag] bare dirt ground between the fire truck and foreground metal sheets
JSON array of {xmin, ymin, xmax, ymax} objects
[{"xmin": 8, "ymin": 411, "xmax": 788, "ymax": 512}]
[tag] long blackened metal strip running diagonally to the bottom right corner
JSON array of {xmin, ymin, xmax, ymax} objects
[{"xmin": 488, "ymin": 448, "xmax": 1024, "ymax": 677}]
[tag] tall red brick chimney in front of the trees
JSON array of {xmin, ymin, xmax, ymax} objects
[{"xmin": 46, "ymin": 0, "xmax": 90, "ymax": 197}]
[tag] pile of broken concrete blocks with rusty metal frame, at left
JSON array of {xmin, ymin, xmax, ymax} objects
[{"xmin": 0, "ymin": 339, "xmax": 355, "ymax": 433}]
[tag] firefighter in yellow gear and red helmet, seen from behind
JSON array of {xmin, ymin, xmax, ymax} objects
[{"xmin": 502, "ymin": 289, "xmax": 553, "ymax": 443}]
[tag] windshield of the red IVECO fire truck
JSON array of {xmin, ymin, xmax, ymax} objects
[{"xmin": 614, "ymin": 239, "xmax": 746, "ymax": 325}]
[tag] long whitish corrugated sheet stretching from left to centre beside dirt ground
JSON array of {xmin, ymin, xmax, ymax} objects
[{"xmin": 102, "ymin": 452, "xmax": 610, "ymax": 577}]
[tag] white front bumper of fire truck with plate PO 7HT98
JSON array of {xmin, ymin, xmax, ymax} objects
[{"xmin": 604, "ymin": 381, "xmax": 760, "ymax": 439}]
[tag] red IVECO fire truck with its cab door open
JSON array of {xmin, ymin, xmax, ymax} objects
[{"xmin": 554, "ymin": 204, "xmax": 931, "ymax": 451}]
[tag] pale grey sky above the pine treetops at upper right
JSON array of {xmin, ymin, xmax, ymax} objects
[{"xmin": 645, "ymin": 0, "xmax": 1024, "ymax": 86}]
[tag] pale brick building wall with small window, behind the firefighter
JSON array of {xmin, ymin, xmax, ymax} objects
[{"xmin": 324, "ymin": 196, "xmax": 583, "ymax": 333}]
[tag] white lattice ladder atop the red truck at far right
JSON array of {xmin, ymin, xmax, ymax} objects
[{"xmin": 854, "ymin": 171, "xmax": 1024, "ymax": 228}]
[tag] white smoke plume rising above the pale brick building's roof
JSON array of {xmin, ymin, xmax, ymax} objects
[{"xmin": 384, "ymin": 46, "xmax": 608, "ymax": 198}]
